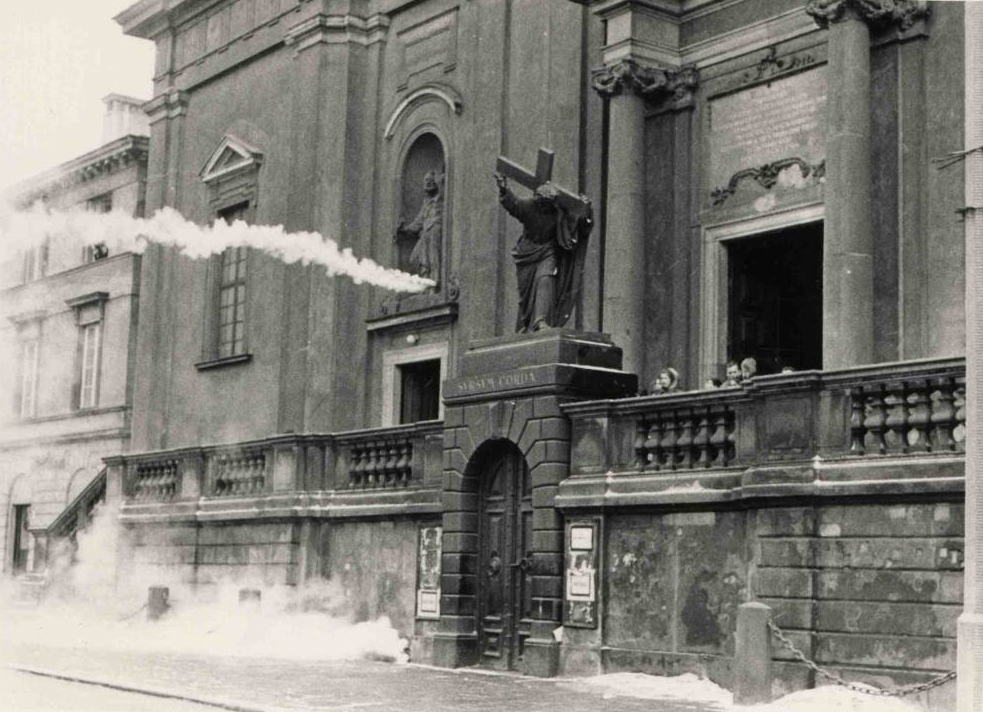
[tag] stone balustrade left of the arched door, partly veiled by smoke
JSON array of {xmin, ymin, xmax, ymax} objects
[{"xmin": 107, "ymin": 421, "xmax": 443, "ymax": 504}]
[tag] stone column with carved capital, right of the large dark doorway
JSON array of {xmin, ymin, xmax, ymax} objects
[{"xmin": 806, "ymin": 0, "xmax": 926, "ymax": 368}]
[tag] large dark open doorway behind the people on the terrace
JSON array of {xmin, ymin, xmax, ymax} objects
[{"xmin": 727, "ymin": 222, "xmax": 823, "ymax": 374}]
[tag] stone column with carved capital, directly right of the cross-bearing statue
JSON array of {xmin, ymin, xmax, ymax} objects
[{"xmin": 593, "ymin": 59, "xmax": 696, "ymax": 373}]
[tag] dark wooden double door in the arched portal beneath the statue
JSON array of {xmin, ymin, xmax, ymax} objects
[{"xmin": 478, "ymin": 443, "xmax": 533, "ymax": 670}]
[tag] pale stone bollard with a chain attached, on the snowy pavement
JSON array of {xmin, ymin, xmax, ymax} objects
[{"xmin": 733, "ymin": 603, "xmax": 771, "ymax": 705}]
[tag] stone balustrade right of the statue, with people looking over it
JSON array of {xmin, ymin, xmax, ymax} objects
[{"xmin": 558, "ymin": 359, "xmax": 965, "ymax": 507}]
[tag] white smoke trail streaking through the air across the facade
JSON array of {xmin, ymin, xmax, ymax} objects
[{"xmin": 0, "ymin": 205, "xmax": 434, "ymax": 292}]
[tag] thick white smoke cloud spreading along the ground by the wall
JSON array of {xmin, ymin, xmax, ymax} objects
[{"xmin": 0, "ymin": 507, "xmax": 407, "ymax": 662}]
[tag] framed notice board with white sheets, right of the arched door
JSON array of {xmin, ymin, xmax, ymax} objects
[{"xmin": 563, "ymin": 519, "xmax": 600, "ymax": 628}]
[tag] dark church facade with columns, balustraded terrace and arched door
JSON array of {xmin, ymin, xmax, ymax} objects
[{"xmin": 107, "ymin": 0, "xmax": 965, "ymax": 694}]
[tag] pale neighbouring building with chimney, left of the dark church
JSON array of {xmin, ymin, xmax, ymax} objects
[{"xmin": 0, "ymin": 94, "xmax": 149, "ymax": 576}]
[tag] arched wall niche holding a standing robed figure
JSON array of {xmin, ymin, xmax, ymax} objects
[{"xmin": 396, "ymin": 128, "xmax": 447, "ymax": 285}]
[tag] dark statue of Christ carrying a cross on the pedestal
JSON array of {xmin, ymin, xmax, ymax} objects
[{"xmin": 495, "ymin": 148, "xmax": 594, "ymax": 333}]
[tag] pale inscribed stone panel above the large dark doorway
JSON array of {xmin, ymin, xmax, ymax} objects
[{"xmin": 709, "ymin": 67, "xmax": 826, "ymax": 186}]
